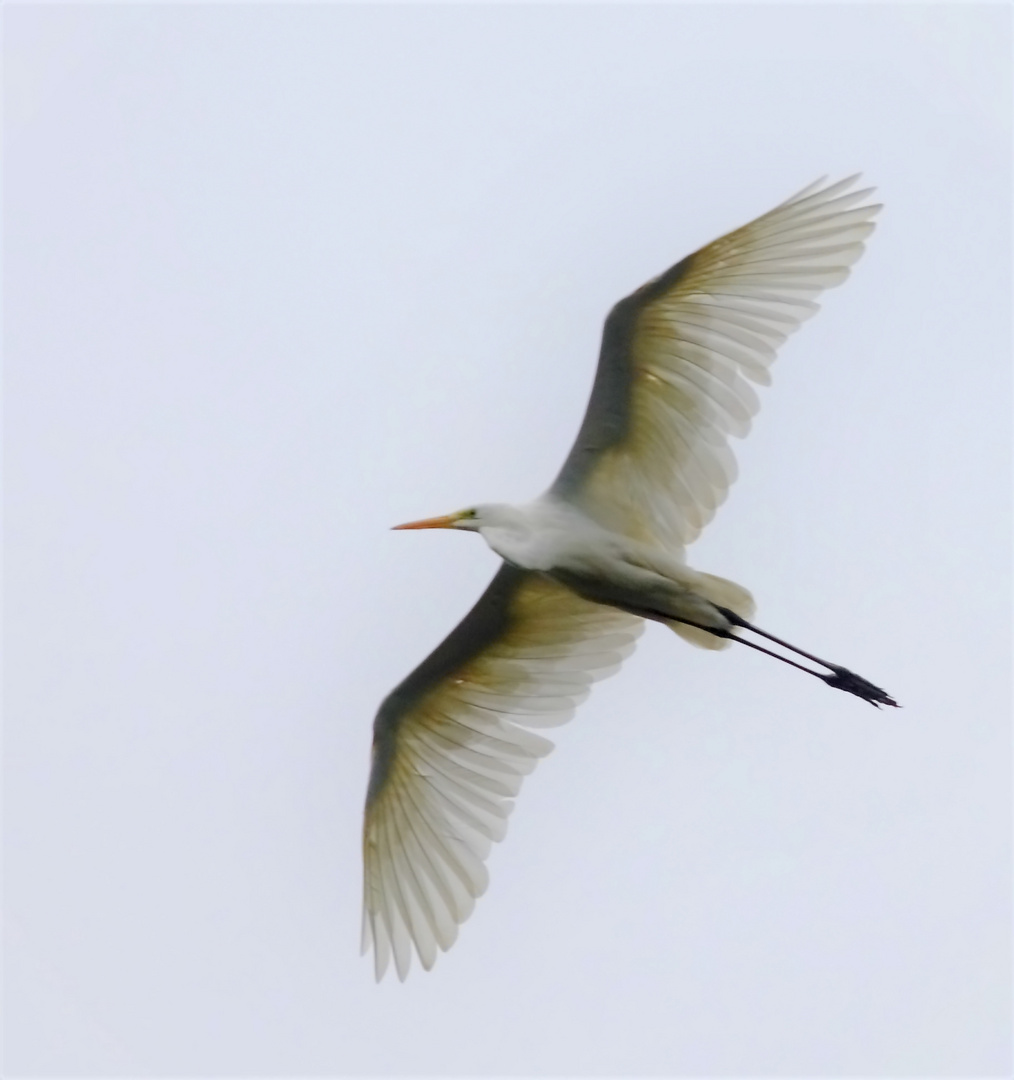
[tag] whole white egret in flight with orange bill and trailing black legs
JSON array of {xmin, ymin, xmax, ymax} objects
[{"xmin": 363, "ymin": 177, "xmax": 896, "ymax": 980}]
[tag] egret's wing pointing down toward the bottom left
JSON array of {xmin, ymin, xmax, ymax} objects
[{"xmin": 363, "ymin": 563, "xmax": 643, "ymax": 978}]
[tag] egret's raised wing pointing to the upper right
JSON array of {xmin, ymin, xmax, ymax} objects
[{"xmin": 550, "ymin": 177, "xmax": 880, "ymax": 549}]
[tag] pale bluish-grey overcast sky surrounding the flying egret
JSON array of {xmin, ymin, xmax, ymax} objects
[{"xmin": 4, "ymin": 4, "xmax": 1012, "ymax": 1077}]
